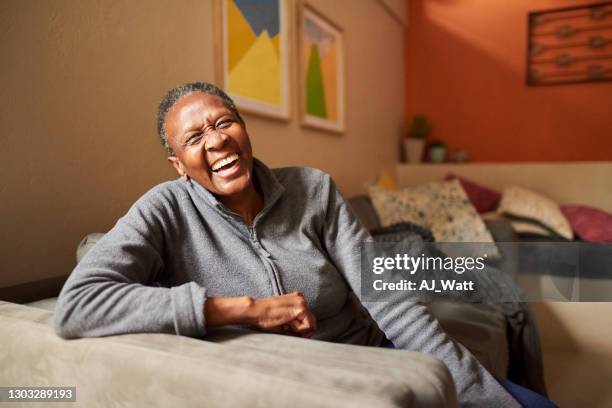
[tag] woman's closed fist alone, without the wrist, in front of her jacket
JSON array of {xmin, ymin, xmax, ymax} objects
[{"xmin": 250, "ymin": 292, "xmax": 317, "ymax": 337}]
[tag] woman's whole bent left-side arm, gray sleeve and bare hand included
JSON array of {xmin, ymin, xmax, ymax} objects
[{"xmin": 54, "ymin": 184, "xmax": 316, "ymax": 338}]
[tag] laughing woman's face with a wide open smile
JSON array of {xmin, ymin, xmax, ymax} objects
[{"xmin": 166, "ymin": 92, "xmax": 253, "ymax": 201}]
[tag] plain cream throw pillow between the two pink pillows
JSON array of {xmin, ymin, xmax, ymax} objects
[{"xmin": 497, "ymin": 187, "xmax": 574, "ymax": 240}]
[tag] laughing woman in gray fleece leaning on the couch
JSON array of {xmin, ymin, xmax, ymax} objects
[{"xmin": 55, "ymin": 83, "xmax": 548, "ymax": 407}]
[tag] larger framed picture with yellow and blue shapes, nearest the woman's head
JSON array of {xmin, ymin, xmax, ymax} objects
[{"xmin": 214, "ymin": 0, "xmax": 291, "ymax": 119}]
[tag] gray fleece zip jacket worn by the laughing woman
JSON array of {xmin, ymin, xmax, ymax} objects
[{"xmin": 54, "ymin": 160, "xmax": 518, "ymax": 407}]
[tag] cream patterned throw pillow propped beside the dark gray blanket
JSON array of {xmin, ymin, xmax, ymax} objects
[{"xmin": 369, "ymin": 180, "xmax": 497, "ymax": 255}]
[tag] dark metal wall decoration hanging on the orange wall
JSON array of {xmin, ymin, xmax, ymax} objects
[{"xmin": 527, "ymin": 1, "xmax": 612, "ymax": 86}]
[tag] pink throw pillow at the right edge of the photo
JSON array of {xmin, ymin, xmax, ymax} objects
[{"xmin": 561, "ymin": 205, "xmax": 612, "ymax": 242}]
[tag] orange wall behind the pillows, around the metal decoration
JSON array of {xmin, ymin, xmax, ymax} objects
[{"xmin": 405, "ymin": 0, "xmax": 612, "ymax": 161}]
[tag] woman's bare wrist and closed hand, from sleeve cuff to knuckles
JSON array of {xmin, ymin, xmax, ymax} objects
[{"xmin": 204, "ymin": 292, "xmax": 317, "ymax": 337}]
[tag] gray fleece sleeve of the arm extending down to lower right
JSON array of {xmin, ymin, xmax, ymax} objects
[{"xmin": 321, "ymin": 176, "xmax": 519, "ymax": 407}]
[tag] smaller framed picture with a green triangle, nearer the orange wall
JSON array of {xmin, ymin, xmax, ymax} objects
[{"xmin": 299, "ymin": 3, "xmax": 345, "ymax": 133}]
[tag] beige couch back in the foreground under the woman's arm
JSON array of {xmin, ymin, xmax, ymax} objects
[{"xmin": 0, "ymin": 300, "xmax": 457, "ymax": 408}]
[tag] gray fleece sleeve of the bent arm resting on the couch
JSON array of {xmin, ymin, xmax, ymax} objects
[{"xmin": 54, "ymin": 192, "xmax": 206, "ymax": 338}]
